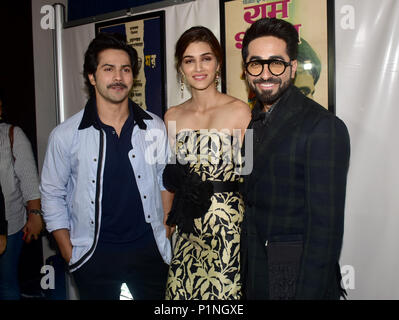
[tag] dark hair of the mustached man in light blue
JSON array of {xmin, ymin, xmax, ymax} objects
[{"xmin": 83, "ymin": 33, "xmax": 138, "ymax": 97}]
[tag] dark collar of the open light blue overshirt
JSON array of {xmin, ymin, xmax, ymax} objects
[{"xmin": 79, "ymin": 97, "xmax": 152, "ymax": 130}]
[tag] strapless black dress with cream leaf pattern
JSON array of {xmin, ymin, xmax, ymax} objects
[{"xmin": 164, "ymin": 130, "xmax": 244, "ymax": 300}]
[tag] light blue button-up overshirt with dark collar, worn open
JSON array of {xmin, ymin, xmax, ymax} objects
[{"xmin": 40, "ymin": 99, "xmax": 171, "ymax": 271}]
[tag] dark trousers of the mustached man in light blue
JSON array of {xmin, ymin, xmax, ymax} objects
[{"xmin": 72, "ymin": 232, "xmax": 169, "ymax": 300}]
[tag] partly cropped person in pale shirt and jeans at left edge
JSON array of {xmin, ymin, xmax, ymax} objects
[{"xmin": 0, "ymin": 93, "xmax": 43, "ymax": 300}]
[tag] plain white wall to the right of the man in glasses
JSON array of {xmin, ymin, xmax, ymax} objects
[{"xmin": 335, "ymin": 0, "xmax": 399, "ymax": 299}]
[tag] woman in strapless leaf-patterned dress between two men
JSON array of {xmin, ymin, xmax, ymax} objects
[{"xmin": 164, "ymin": 27, "xmax": 251, "ymax": 300}]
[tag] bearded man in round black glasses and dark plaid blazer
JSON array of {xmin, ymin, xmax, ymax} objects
[{"xmin": 241, "ymin": 18, "xmax": 350, "ymax": 299}]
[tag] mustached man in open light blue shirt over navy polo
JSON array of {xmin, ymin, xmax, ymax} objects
[{"xmin": 40, "ymin": 34, "xmax": 171, "ymax": 300}]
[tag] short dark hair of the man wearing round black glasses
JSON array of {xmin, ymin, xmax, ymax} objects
[{"xmin": 241, "ymin": 18, "xmax": 299, "ymax": 62}]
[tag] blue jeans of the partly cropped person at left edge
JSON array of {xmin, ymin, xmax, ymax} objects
[{"xmin": 0, "ymin": 230, "xmax": 23, "ymax": 300}]
